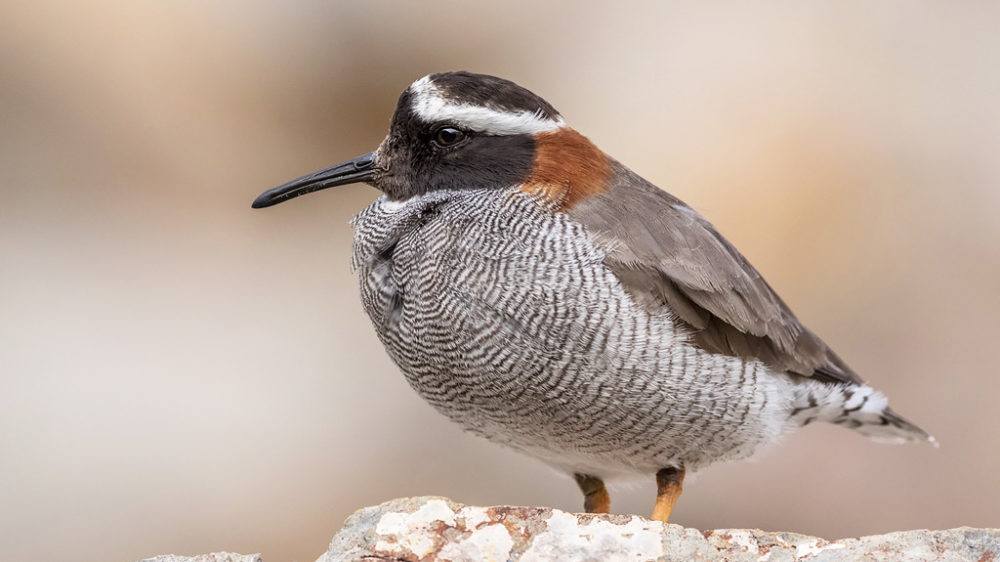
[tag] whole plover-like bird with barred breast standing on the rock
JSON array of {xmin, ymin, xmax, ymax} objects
[{"xmin": 252, "ymin": 71, "xmax": 936, "ymax": 522}]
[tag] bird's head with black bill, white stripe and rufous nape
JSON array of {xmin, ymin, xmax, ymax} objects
[{"xmin": 253, "ymin": 72, "xmax": 611, "ymax": 208}]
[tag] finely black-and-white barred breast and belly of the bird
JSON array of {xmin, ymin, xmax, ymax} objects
[{"xmin": 353, "ymin": 190, "xmax": 787, "ymax": 474}]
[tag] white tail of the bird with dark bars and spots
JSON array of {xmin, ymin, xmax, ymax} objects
[{"xmin": 789, "ymin": 380, "xmax": 937, "ymax": 446}]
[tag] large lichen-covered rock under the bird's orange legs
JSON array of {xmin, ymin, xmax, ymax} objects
[{"xmin": 317, "ymin": 497, "xmax": 1000, "ymax": 562}]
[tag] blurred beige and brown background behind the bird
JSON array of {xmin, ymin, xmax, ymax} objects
[{"xmin": 0, "ymin": 0, "xmax": 1000, "ymax": 561}]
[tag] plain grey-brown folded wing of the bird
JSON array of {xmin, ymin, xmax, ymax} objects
[{"xmin": 568, "ymin": 162, "xmax": 861, "ymax": 383}]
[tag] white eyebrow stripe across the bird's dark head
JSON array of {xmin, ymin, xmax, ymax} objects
[{"xmin": 410, "ymin": 76, "xmax": 566, "ymax": 135}]
